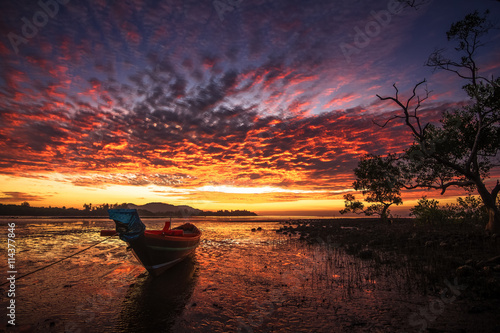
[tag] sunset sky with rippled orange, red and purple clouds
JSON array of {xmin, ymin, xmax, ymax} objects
[{"xmin": 0, "ymin": 0, "xmax": 500, "ymax": 216}]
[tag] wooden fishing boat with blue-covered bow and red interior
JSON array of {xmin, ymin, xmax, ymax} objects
[{"xmin": 101, "ymin": 209, "xmax": 201, "ymax": 276}]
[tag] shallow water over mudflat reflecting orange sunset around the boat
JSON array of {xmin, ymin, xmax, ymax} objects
[{"xmin": 0, "ymin": 219, "xmax": 428, "ymax": 332}]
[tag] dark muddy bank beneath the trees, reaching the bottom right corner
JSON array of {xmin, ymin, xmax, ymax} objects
[{"xmin": 276, "ymin": 218, "xmax": 500, "ymax": 332}]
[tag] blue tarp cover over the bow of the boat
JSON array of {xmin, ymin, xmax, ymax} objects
[{"xmin": 108, "ymin": 209, "xmax": 146, "ymax": 242}]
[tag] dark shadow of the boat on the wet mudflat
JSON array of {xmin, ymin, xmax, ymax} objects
[{"xmin": 116, "ymin": 254, "xmax": 198, "ymax": 332}]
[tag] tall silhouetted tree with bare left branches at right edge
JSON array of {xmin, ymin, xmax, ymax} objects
[{"xmin": 377, "ymin": 12, "xmax": 500, "ymax": 232}]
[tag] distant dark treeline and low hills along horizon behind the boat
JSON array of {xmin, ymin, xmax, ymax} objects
[{"xmin": 0, "ymin": 202, "xmax": 257, "ymax": 218}]
